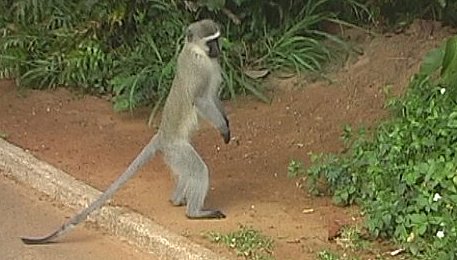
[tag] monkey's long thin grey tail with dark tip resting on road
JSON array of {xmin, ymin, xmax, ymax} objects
[{"xmin": 21, "ymin": 135, "xmax": 159, "ymax": 244}]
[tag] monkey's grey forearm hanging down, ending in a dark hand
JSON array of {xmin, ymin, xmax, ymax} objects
[{"xmin": 195, "ymin": 97, "xmax": 230, "ymax": 144}]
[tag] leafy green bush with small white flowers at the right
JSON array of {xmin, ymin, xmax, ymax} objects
[{"xmin": 289, "ymin": 37, "xmax": 457, "ymax": 259}]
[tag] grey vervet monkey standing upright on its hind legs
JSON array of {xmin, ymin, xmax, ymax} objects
[{"xmin": 21, "ymin": 20, "xmax": 230, "ymax": 244}]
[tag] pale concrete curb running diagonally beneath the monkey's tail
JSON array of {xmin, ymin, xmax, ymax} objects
[{"xmin": 0, "ymin": 138, "xmax": 226, "ymax": 260}]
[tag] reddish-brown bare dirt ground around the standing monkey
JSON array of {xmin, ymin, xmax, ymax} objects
[{"xmin": 0, "ymin": 23, "xmax": 450, "ymax": 259}]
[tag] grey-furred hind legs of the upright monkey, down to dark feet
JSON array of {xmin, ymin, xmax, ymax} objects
[{"xmin": 165, "ymin": 143, "xmax": 225, "ymax": 219}]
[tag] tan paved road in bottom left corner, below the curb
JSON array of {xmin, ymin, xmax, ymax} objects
[{"xmin": 0, "ymin": 173, "xmax": 153, "ymax": 260}]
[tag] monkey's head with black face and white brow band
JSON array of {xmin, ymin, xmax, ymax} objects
[{"xmin": 186, "ymin": 19, "xmax": 221, "ymax": 58}]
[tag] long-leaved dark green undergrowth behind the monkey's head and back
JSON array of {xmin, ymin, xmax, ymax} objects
[{"xmin": 0, "ymin": 0, "xmax": 368, "ymax": 110}]
